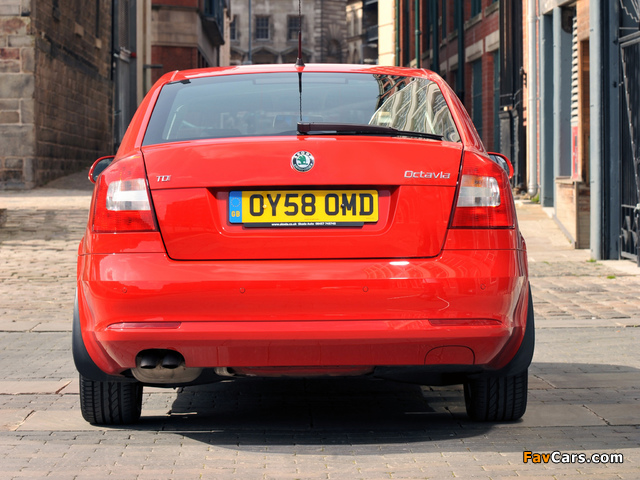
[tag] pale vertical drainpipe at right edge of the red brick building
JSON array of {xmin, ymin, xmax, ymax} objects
[{"xmin": 527, "ymin": 0, "xmax": 538, "ymax": 197}]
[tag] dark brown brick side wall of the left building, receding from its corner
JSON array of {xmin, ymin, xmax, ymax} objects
[{"xmin": 34, "ymin": 0, "xmax": 113, "ymax": 184}]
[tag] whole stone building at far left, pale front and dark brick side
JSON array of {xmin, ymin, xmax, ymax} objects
[{"xmin": 0, "ymin": 0, "xmax": 112, "ymax": 188}]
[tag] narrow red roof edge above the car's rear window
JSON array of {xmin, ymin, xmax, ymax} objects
[{"xmin": 161, "ymin": 63, "xmax": 438, "ymax": 83}]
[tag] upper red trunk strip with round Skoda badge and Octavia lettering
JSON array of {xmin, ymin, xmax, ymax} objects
[{"xmin": 142, "ymin": 136, "xmax": 462, "ymax": 191}]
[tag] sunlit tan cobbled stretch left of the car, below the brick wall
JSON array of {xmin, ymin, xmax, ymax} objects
[{"xmin": 0, "ymin": 171, "xmax": 93, "ymax": 332}]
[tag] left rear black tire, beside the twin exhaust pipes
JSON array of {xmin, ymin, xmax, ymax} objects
[{"xmin": 80, "ymin": 375, "xmax": 142, "ymax": 425}]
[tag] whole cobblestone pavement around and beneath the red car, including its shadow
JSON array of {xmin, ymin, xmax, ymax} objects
[{"xmin": 0, "ymin": 174, "xmax": 640, "ymax": 479}]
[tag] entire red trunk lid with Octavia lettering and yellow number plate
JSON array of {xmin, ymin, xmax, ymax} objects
[{"xmin": 142, "ymin": 136, "xmax": 462, "ymax": 260}]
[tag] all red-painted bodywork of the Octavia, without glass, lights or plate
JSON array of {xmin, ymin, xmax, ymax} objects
[{"xmin": 77, "ymin": 65, "xmax": 530, "ymax": 386}]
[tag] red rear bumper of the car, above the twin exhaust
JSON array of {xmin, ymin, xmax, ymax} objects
[{"xmin": 78, "ymin": 250, "xmax": 528, "ymax": 375}]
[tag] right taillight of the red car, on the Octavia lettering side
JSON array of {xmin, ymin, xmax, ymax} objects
[{"xmin": 451, "ymin": 153, "xmax": 516, "ymax": 228}]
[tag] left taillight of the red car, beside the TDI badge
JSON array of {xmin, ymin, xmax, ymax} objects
[{"xmin": 93, "ymin": 155, "xmax": 156, "ymax": 233}]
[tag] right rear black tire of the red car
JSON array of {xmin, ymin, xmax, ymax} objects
[{"xmin": 464, "ymin": 370, "xmax": 529, "ymax": 422}]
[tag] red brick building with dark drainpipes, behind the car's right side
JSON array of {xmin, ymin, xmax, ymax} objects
[{"xmin": 378, "ymin": 0, "xmax": 526, "ymax": 188}]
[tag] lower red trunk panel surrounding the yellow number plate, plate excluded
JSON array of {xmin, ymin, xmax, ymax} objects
[{"xmin": 153, "ymin": 187, "xmax": 455, "ymax": 260}]
